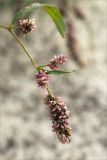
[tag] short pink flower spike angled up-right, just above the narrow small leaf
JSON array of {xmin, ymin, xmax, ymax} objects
[{"xmin": 48, "ymin": 54, "xmax": 66, "ymax": 70}]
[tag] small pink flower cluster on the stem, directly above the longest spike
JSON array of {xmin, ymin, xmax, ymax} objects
[{"xmin": 35, "ymin": 70, "xmax": 49, "ymax": 87}]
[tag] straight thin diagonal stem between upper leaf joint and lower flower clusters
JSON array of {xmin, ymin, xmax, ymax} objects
[{"xmin": 8, "ymin": 29, "xmax": 40, "ymax": 70}]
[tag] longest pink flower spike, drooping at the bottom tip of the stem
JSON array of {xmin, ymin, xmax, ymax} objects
[{"xmin": 45, "ymin": 95, "xmax": 71, "ymax": 144}]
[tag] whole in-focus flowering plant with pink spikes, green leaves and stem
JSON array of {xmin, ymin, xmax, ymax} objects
[{"xmin": 0, "ymin": 3, "xmax": 75, "ymax": 144}]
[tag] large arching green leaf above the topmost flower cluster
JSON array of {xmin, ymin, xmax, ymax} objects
[{"xmin": 11, "ymin": 3, "xmax": 65, "ymax": 37}]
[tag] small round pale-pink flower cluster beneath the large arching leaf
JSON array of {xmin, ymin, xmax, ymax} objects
[{"xmin": 18, "ymin": 19, "xmax": 37, "ymax": 35}]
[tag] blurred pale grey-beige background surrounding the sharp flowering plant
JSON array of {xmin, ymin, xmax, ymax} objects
[{"xmin": 0, "ymin": 0, "xmax": 107, "ymax": 160}]
